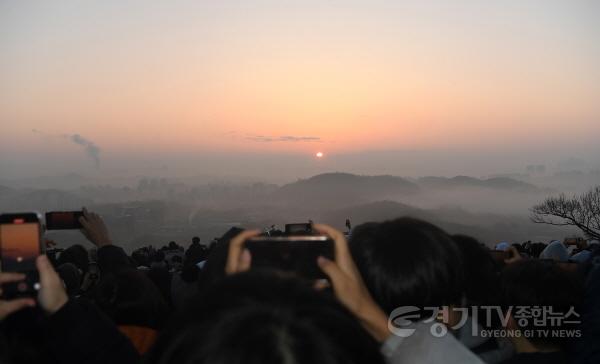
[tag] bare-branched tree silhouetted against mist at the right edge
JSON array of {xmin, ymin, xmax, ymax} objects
[{"xmin": 531, "ymin": 186, "xmax": 600, "ymax": 239}]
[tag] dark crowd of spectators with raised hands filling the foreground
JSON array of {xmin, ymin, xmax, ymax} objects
[{"xmin": 0, "ymin": 210, "xmax": 600, "ymax": 364}]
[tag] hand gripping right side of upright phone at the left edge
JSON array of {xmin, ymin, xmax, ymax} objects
[{"xmin": 35, "ymin": 255, "xmax": 69, "ymax": 314}]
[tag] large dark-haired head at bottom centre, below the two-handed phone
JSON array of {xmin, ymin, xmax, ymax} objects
[{"xmin": 148, "ymin": 270, "xmax": 383, "ymax": 364}]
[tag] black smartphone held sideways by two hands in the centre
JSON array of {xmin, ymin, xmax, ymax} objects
[{"xmin": 245, "ymin": 235, "xmax": 334, "ymax": 279}]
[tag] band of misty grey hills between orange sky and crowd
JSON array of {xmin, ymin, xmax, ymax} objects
[{"xmin": 0, "ymin": 172, "xmax": 576, "ymax": 249}]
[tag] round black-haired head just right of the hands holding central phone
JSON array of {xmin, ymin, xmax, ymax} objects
[{"xmin": 350, "ymin": 217, "xmax": 464, "ymax": 313}]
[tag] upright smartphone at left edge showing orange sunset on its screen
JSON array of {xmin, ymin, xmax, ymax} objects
[{"xmin": 0, "ymin": 213, "xmax": 44, "ymax": 299}]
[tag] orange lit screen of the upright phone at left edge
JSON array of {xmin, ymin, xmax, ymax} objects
[{"xmin": 0, "ymin": 219, "xmax": 40, "ymax": 272}]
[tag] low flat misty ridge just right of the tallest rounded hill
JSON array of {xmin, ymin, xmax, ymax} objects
[{"xmin": 418, "ymin": 176, "xmax": 542, "ymax": 192}]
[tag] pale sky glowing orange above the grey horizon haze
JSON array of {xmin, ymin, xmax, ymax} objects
[{"xmin": 0, "ymin": 0, "xmax": 600, "ymax": 178}]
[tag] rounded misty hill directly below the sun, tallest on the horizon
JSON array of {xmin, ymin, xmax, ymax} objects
[{"xmin": 275, "ymin": 173, "xmax": 419, "ymax": 206}]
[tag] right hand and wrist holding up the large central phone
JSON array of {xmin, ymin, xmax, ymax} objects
[{"xmin": 313, "ymin": 224, "xmax": 390, "ymax": 342}]
